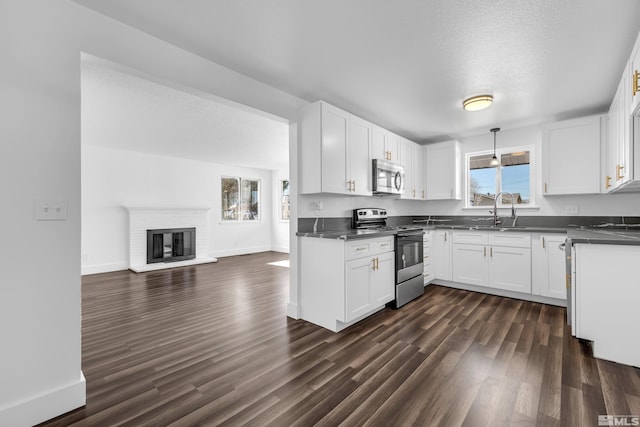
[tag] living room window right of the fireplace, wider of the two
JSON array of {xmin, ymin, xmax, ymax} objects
[{"xmin": 222, "ymin": 177, "xmax": 260, "ymax": 221}]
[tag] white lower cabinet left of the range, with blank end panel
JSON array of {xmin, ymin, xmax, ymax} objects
[{"xmin": 299, "ymin": 236, "xmax": 395, "ymax": 332}]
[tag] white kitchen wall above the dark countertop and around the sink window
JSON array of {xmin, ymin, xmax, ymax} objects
[{"xmin": 298, "ymin": 122, "xmax": 640, "ymax": 217}]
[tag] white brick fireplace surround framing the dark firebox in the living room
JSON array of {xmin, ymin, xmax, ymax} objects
[{"xmin": 126, "ymin": 207, "xmax": 217, "ymax": 273}]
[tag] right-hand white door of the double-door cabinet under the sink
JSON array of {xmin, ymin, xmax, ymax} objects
[{"xmin": 488, "ymin": 246, "xmax": 531, "ymax": 294}]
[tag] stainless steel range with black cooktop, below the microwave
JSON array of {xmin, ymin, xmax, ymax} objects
[{"xmin": 353, "ymin": 208, "xmax": 424, "ymax": 308}]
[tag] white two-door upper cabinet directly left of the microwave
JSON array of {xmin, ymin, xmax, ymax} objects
[{"xmin": 300, "ymin": 101, "xmax": 372, "ymax": 196}]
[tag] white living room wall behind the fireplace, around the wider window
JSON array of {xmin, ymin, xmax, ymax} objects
[{"xmin": 82, "ymin": 145, "xmax": 278, "ymax": 274}]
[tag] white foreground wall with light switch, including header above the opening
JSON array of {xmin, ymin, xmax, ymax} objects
[{"xmin": 0, "ymin": 0, "xmax": 305, "ymax": 427}]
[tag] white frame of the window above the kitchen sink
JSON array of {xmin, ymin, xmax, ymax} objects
[{"xmin": 464, "ymin": 145, "xmax": 538, "ymax": 210}]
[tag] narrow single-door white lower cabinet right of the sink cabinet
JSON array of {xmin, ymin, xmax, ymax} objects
[{"xmin": 531, "ymin": 233, "xmax": 567, "ymax": 300}]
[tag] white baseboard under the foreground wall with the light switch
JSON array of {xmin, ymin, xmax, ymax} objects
[{"xmin": 0, "ymin": 372, "xmax": 87, "ymax": 427}]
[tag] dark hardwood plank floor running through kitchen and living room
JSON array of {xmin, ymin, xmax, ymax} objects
[{"xmin": 42, "ymin": 252, "xmax": 640, "ymax": 426}]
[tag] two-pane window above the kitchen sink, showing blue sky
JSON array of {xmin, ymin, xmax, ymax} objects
[{"xmin": 466, "ymin": 146, "xmax": 535, "ymax": 208}]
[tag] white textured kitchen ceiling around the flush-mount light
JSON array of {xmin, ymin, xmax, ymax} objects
[{"xmin": 76, "ymin": 0, "xmax": 640, "ymax": 148}]
